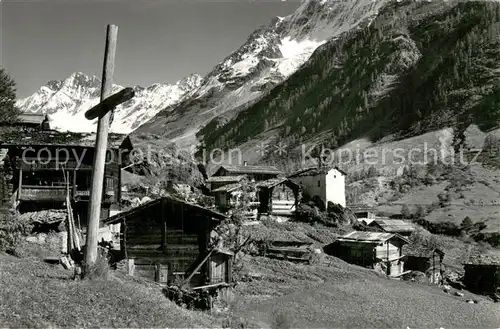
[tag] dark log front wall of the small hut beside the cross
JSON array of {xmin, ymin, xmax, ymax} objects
[{"xmin": 122, "ymin": 201, "xmax": 216, "ymax": 285}]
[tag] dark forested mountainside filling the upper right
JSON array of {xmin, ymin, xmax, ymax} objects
[{"xmin": 199, "ymin": 0, "xmax": 500, "ymax": 154}]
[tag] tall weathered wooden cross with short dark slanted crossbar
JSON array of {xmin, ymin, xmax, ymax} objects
[{"xmin": 84, "ymin": 25, "xmax": 134, "ymax": 275}]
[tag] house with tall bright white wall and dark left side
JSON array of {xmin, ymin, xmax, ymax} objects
[{"xmin": 288, "ymin": 167, "xmax": 346, "ymax": 207}]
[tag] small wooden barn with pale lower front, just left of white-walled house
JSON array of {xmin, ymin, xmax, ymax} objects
[{"xmin": 257, "ymin": 178, "xmax": 300, "ymax": 216}]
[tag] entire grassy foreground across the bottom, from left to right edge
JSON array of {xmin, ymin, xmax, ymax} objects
[{"xmin": 0, "ymin": 251, "xmax": 500, "ymax": 328}]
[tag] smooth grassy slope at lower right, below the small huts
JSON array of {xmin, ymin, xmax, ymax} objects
[{"xmin": 236, "ymin": 258, "xmax": 500, "ymax": 328}]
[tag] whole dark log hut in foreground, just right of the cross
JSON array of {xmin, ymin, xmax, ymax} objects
[{"xmin": 103, "ymin": 197, "xmax": 232, "ymax": 287}]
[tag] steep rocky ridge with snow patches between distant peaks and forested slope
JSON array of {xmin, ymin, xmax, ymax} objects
[{"xmin": 134, "ymin": 0, "xmax": 387, "ymax": 147}]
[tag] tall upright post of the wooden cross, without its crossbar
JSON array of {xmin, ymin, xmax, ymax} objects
[{"xmin": 85, "ymin": 25, "xmax": 118, "ymax": 266}]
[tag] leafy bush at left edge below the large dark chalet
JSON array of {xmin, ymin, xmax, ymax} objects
[{"xmin": 0, "ymin": 211, "xmax": 33, "ymax": 252}]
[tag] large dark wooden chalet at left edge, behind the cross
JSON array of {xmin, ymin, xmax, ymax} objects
[{"xmin": 0, "ymin": 127, "xmax": 132, "ymax": 225}]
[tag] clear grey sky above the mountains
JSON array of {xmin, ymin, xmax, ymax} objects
[{"xmin": 0, "ymin": 0, "xmax": 300, "ymax": 97}]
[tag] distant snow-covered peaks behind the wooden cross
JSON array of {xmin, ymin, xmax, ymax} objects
[{"xmin": 17, "ymin": 72, "xmax": 203, "ymax": 133}]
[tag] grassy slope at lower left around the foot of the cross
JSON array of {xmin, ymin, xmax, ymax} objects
[{"xmin": 0, "ymin": 254, "xmax": 220, "ymax": 328}]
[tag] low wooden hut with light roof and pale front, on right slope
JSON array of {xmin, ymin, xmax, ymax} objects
[{"xmin": 324, "ymin": 231, "xmax": 409, "ymax": 276}]
